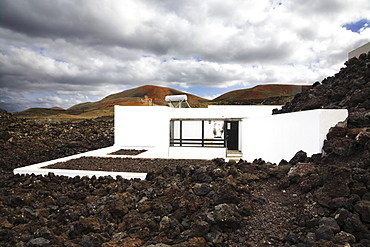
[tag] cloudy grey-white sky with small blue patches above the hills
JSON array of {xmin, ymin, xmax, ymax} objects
[{"xmin": 0, "ymin": 0, "xmax": 370, "ymax": 111}]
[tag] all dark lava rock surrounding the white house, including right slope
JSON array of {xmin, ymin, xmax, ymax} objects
[{"xmin": 0, "ymin": 51, "xmax": 370, "ymax": 247}]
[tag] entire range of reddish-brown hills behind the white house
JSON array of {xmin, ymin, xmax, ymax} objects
[{"xmin": 14, "ymin": 84, "xmax": 310, "ymax": 119}]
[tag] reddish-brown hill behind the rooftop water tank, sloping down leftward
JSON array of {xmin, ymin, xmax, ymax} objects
[{"xmin": 14, "ymin": 85, "xmax": 209, "ymax": 119}]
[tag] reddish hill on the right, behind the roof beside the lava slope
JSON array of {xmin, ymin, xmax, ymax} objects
[{"xmin": 212, "ymin": 84, "xmax": 311, "ymax": 104}]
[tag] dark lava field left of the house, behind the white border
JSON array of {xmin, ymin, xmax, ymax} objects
[{"xmin": 0, "ymin": 115, "xmax": 114, "ymax": 171}]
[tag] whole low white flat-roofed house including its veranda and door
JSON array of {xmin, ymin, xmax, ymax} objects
[{"xmin": 115, "ymin": 105, "xmax": 348, "ymax": 163}]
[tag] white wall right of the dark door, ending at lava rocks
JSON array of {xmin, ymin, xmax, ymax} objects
[{"xmin": 241, "ymin": 110, "xmax": 348, "ymax": 163}]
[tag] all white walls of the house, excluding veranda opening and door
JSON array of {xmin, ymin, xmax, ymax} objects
[{"xmin": 115, "ymin": 106, "xmax": 348, "ymax": 163}]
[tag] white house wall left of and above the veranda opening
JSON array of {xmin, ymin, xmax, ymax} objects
[{"xmin": 114, "ymin": 106, "xmax": 278, "ymax": 148}]
